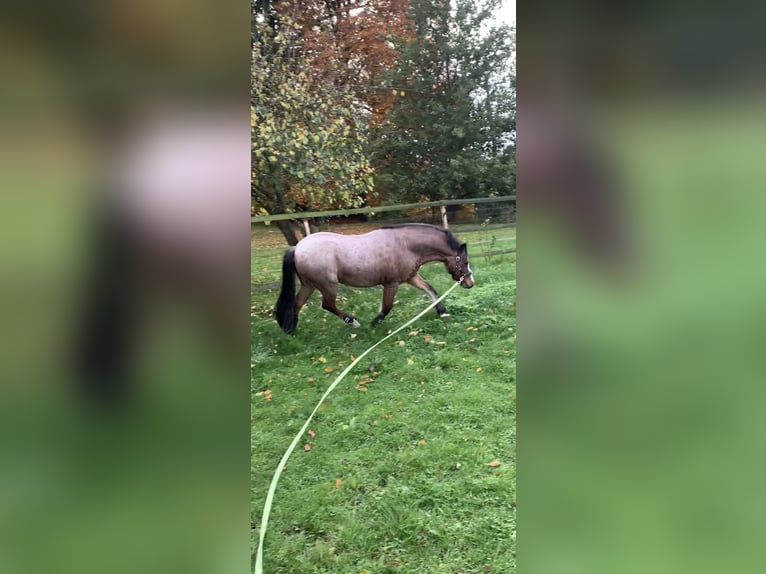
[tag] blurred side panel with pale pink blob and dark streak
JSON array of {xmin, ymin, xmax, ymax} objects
[{"xmin": 0, "ymin": 0, "xmax": 250, "ymax": 574}]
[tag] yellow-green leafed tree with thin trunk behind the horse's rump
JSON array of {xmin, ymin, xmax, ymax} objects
[{"xmin": 251, "ymin": 10, "xmax": 373, "ymax": 245}]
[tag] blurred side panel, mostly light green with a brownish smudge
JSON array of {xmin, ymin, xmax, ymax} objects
[{"xmin": 517, "ymin": 2, "xmax": 766, "ymax": 574}]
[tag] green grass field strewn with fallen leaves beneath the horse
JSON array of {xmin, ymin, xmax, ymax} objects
[{"xmin": 251, "ymin": 223, "xmax": 516, "ymax": 574}]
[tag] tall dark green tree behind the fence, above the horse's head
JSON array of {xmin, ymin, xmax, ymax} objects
[{"xmin": 373, "ymin": 0, "xmax": 515, "ymax": 205}]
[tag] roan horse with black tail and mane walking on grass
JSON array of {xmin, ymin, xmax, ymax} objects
[{"xmin": 275, "ymin": 223, "xmax": 474, "ymax": 333}]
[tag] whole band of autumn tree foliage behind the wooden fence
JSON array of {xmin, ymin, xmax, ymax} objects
[{"xmin": 251, "ymin": 0, "xmax": 516, "ymax": 244}]
